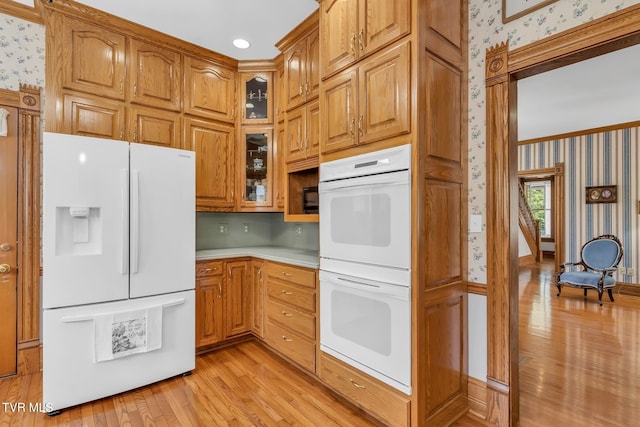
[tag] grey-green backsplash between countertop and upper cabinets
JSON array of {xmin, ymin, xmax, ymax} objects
[{"xmin": 196, "ymin": 212, "xmax": 319, "ymax": 250}]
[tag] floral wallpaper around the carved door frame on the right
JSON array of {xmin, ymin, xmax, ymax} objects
[{"xmin": 468, "ymin": 0, "xmax": 640, "ymax": 283}]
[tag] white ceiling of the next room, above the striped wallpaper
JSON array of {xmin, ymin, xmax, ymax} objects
[{"xmin": 518, "ymin": 45, "xmax": 640, "ymax": 141}]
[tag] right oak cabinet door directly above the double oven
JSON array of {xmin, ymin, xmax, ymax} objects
[{"xmin": 357, "ymin": 42, "xmax": 410, "ymax": 144}]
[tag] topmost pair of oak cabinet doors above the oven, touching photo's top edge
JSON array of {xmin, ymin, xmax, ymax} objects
[{"xmin": 320, "ymin": 0, "xmax": 411, "ymax": 78}]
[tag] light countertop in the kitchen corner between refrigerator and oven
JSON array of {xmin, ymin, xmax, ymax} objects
[{"xmin": 196, "ymin": 246, "xmax": 320, "ymax": 269}]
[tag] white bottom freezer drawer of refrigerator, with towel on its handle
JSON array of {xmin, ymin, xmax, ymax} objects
[{"xmin": 42, "ymin": 290, "xmax": 195, "ymax": 411}]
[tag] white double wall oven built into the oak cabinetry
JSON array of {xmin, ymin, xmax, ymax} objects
[{"xmin": 318, "ymin": 145, "xmax": 411, "ymax": 394}]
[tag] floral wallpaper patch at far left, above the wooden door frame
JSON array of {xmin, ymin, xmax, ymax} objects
[{"xmin": 0, "ymin": 14, "xmax": 45, "ymax": 90}]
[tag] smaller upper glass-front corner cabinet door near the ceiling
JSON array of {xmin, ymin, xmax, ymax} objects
[{"xmin": 241, "ymin": 72, "xmax": 273, "ymax": 125}]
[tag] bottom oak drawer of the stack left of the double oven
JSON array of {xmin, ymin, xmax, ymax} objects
[{"xmin": 265, "ymin": 317, "xmax": 316, "ymax": 372}]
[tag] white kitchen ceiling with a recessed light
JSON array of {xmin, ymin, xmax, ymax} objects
[{"xmin": 72, "ymin": 0, "xmax": 318, "ymax": 60}]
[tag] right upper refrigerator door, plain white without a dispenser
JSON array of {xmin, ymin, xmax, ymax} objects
[{"xmin": 130, "ymin": 144, "xmax": 195, "ymax": 298}]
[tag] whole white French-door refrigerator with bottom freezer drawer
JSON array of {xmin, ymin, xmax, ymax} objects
[{"xmin": 42, "ymin": 133, "xmax": 195, "ymax": 413}]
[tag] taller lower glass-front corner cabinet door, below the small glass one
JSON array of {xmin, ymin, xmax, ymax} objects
[{"xmin": 239, "ymin": 128, "xmax": 273, "ymax": 210}]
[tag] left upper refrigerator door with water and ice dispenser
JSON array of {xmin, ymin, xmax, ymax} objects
[{"xmin": 42, "ymin": 133, "xmax": 129, "ymax": 308}]
